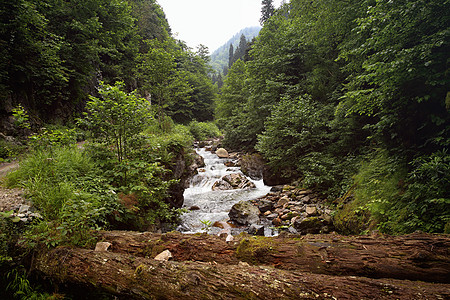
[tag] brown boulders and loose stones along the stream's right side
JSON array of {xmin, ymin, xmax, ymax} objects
[{"xmin": 194, "ymin": 141, "xmax": 334, "ymax": 235}]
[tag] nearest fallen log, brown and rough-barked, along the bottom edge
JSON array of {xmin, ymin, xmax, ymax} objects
[{"xmin": 34, "ymin": 248, "xmax": 450, "ymax": 299}]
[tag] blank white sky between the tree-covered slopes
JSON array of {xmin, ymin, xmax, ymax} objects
[{"xmin": 157, "ymin": 0, "xmax": 282, "ymax": 53}]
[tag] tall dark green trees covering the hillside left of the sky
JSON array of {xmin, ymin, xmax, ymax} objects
[{"xmin": 0, "ymin": 0, "xmax": 215, "ymax": 124}]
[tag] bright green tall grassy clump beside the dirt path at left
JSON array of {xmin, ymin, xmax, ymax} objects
[{"xmin": 7, "ymin": 146, "xmax": 120, "ymax": 246}]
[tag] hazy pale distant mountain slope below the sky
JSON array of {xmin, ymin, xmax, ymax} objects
[{"xmin": 210, "ymin": 26, "xmax": 261, "ymax": 72}]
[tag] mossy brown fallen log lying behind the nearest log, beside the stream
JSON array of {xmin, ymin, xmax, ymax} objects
[{"xmin": 100, "ymin": 231, "xmax": 450, "ymax": 283}]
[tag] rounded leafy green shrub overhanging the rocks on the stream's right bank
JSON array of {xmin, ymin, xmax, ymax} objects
[{"xmin": 256, "ymin": 95, "xmax": 355, "ymax": 197}]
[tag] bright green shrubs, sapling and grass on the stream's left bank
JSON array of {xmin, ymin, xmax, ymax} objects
[{"xmin": 2, "ymin": 84, "xmax": 198, "ymax": 255}]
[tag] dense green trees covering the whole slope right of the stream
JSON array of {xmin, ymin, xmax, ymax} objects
[{"xmin": 216, "ymin": 0, "xmax": 450, "ymax": 233}]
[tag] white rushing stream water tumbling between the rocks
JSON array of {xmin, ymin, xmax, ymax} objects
[{"xmin": 178, "ymin": 148, "xmax": 270, "ymax": 233}]
